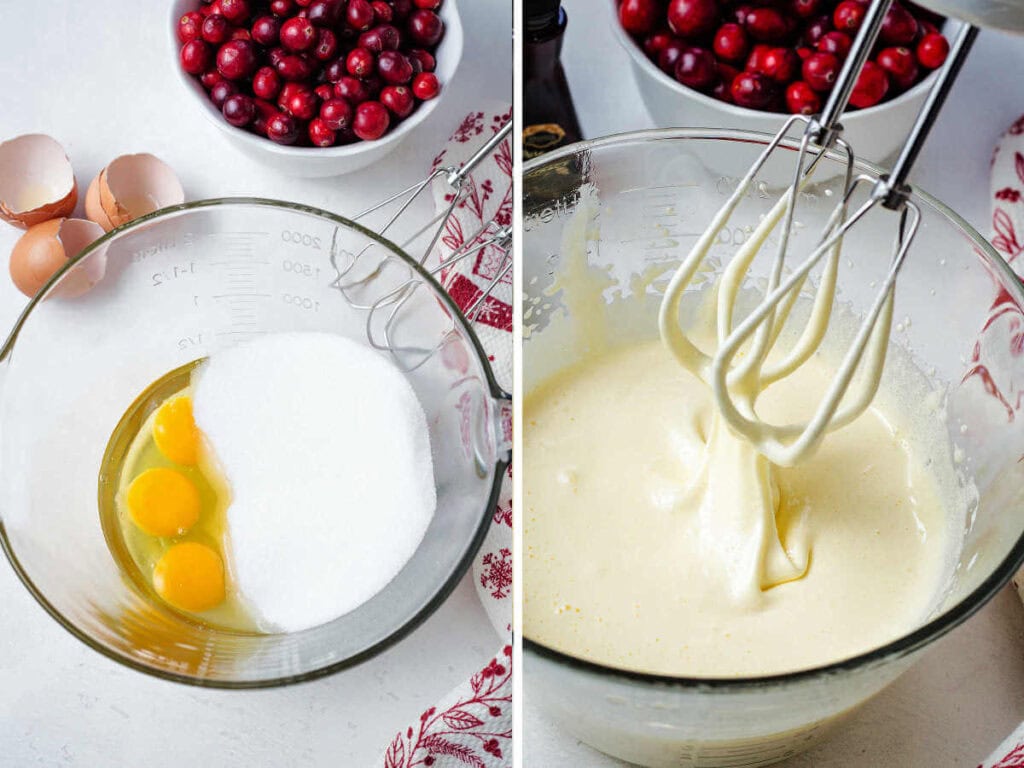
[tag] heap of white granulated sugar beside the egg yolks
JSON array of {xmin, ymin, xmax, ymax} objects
[{"xmin": 193, "ymin": 333, "xmax": 436, "ymax": 632}]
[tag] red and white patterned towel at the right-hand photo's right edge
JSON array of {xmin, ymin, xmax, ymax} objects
[{"xmin": 972, "ymin": 116, "xmax": 1024, "ymax": 768}]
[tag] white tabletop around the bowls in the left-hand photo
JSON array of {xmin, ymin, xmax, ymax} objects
[{"xmin": 0, "ymin": 0, "xmax": 512, "ymax": 768}]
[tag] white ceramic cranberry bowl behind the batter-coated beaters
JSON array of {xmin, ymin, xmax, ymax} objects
[{"xmin": 605, "ymin": 0, "xmax": 961, "ymax": 163}]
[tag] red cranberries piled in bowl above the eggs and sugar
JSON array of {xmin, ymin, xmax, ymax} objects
[{"xmin": 177, "ymin": 0, "xmax": 444, "ymax": 146}]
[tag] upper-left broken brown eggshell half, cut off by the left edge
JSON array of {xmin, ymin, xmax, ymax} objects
[{"xmin": 0, "ymin": 133, "xmax": 78, "ymax": 229}]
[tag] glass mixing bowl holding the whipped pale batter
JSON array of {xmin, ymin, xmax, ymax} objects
[{"xmin": 523, "ymin": 129, "xmax": 1024, "ymax": 768}]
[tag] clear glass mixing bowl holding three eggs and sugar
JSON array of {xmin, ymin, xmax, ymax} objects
[{"xmin": 0, "ymin": 199, "xmax": 509, "ymax": 687}]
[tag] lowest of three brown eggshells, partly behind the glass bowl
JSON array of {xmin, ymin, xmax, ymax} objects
[{"xmin": 10, "ymin": 219, "xmax": 106, "ymax": 298}]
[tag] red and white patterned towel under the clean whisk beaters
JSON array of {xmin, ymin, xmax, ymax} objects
[{"xmin": 382, "ymin": 104, "xmax": 513, "ymax": 768}]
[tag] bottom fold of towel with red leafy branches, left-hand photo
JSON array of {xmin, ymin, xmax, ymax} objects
[{"xmin": 383, "ymin": 645, "xmax": 512, "ymax": 768}]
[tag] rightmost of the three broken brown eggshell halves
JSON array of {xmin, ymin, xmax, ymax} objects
[{"xmin": 97, "ymin": 154, "xmax": 185, "ymax": 226}]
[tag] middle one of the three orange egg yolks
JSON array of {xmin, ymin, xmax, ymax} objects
[{"xmin": 126, "ymin": 467, "xmax": 203, "ymax": 537}]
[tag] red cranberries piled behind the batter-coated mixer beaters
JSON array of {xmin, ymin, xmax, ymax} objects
[{"xmin": 618, "ymin": 0, "xmax": 949, "ymax": 115}]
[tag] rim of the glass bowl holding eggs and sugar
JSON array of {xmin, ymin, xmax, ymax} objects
[{"xmin": 0, "ymin": 197, "xmax": 512, "ymax": 690}]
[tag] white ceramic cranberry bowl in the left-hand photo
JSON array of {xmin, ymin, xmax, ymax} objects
[{"xmin": 167, "ymin": 0, "xmax": 463, "ymax": 178}]
